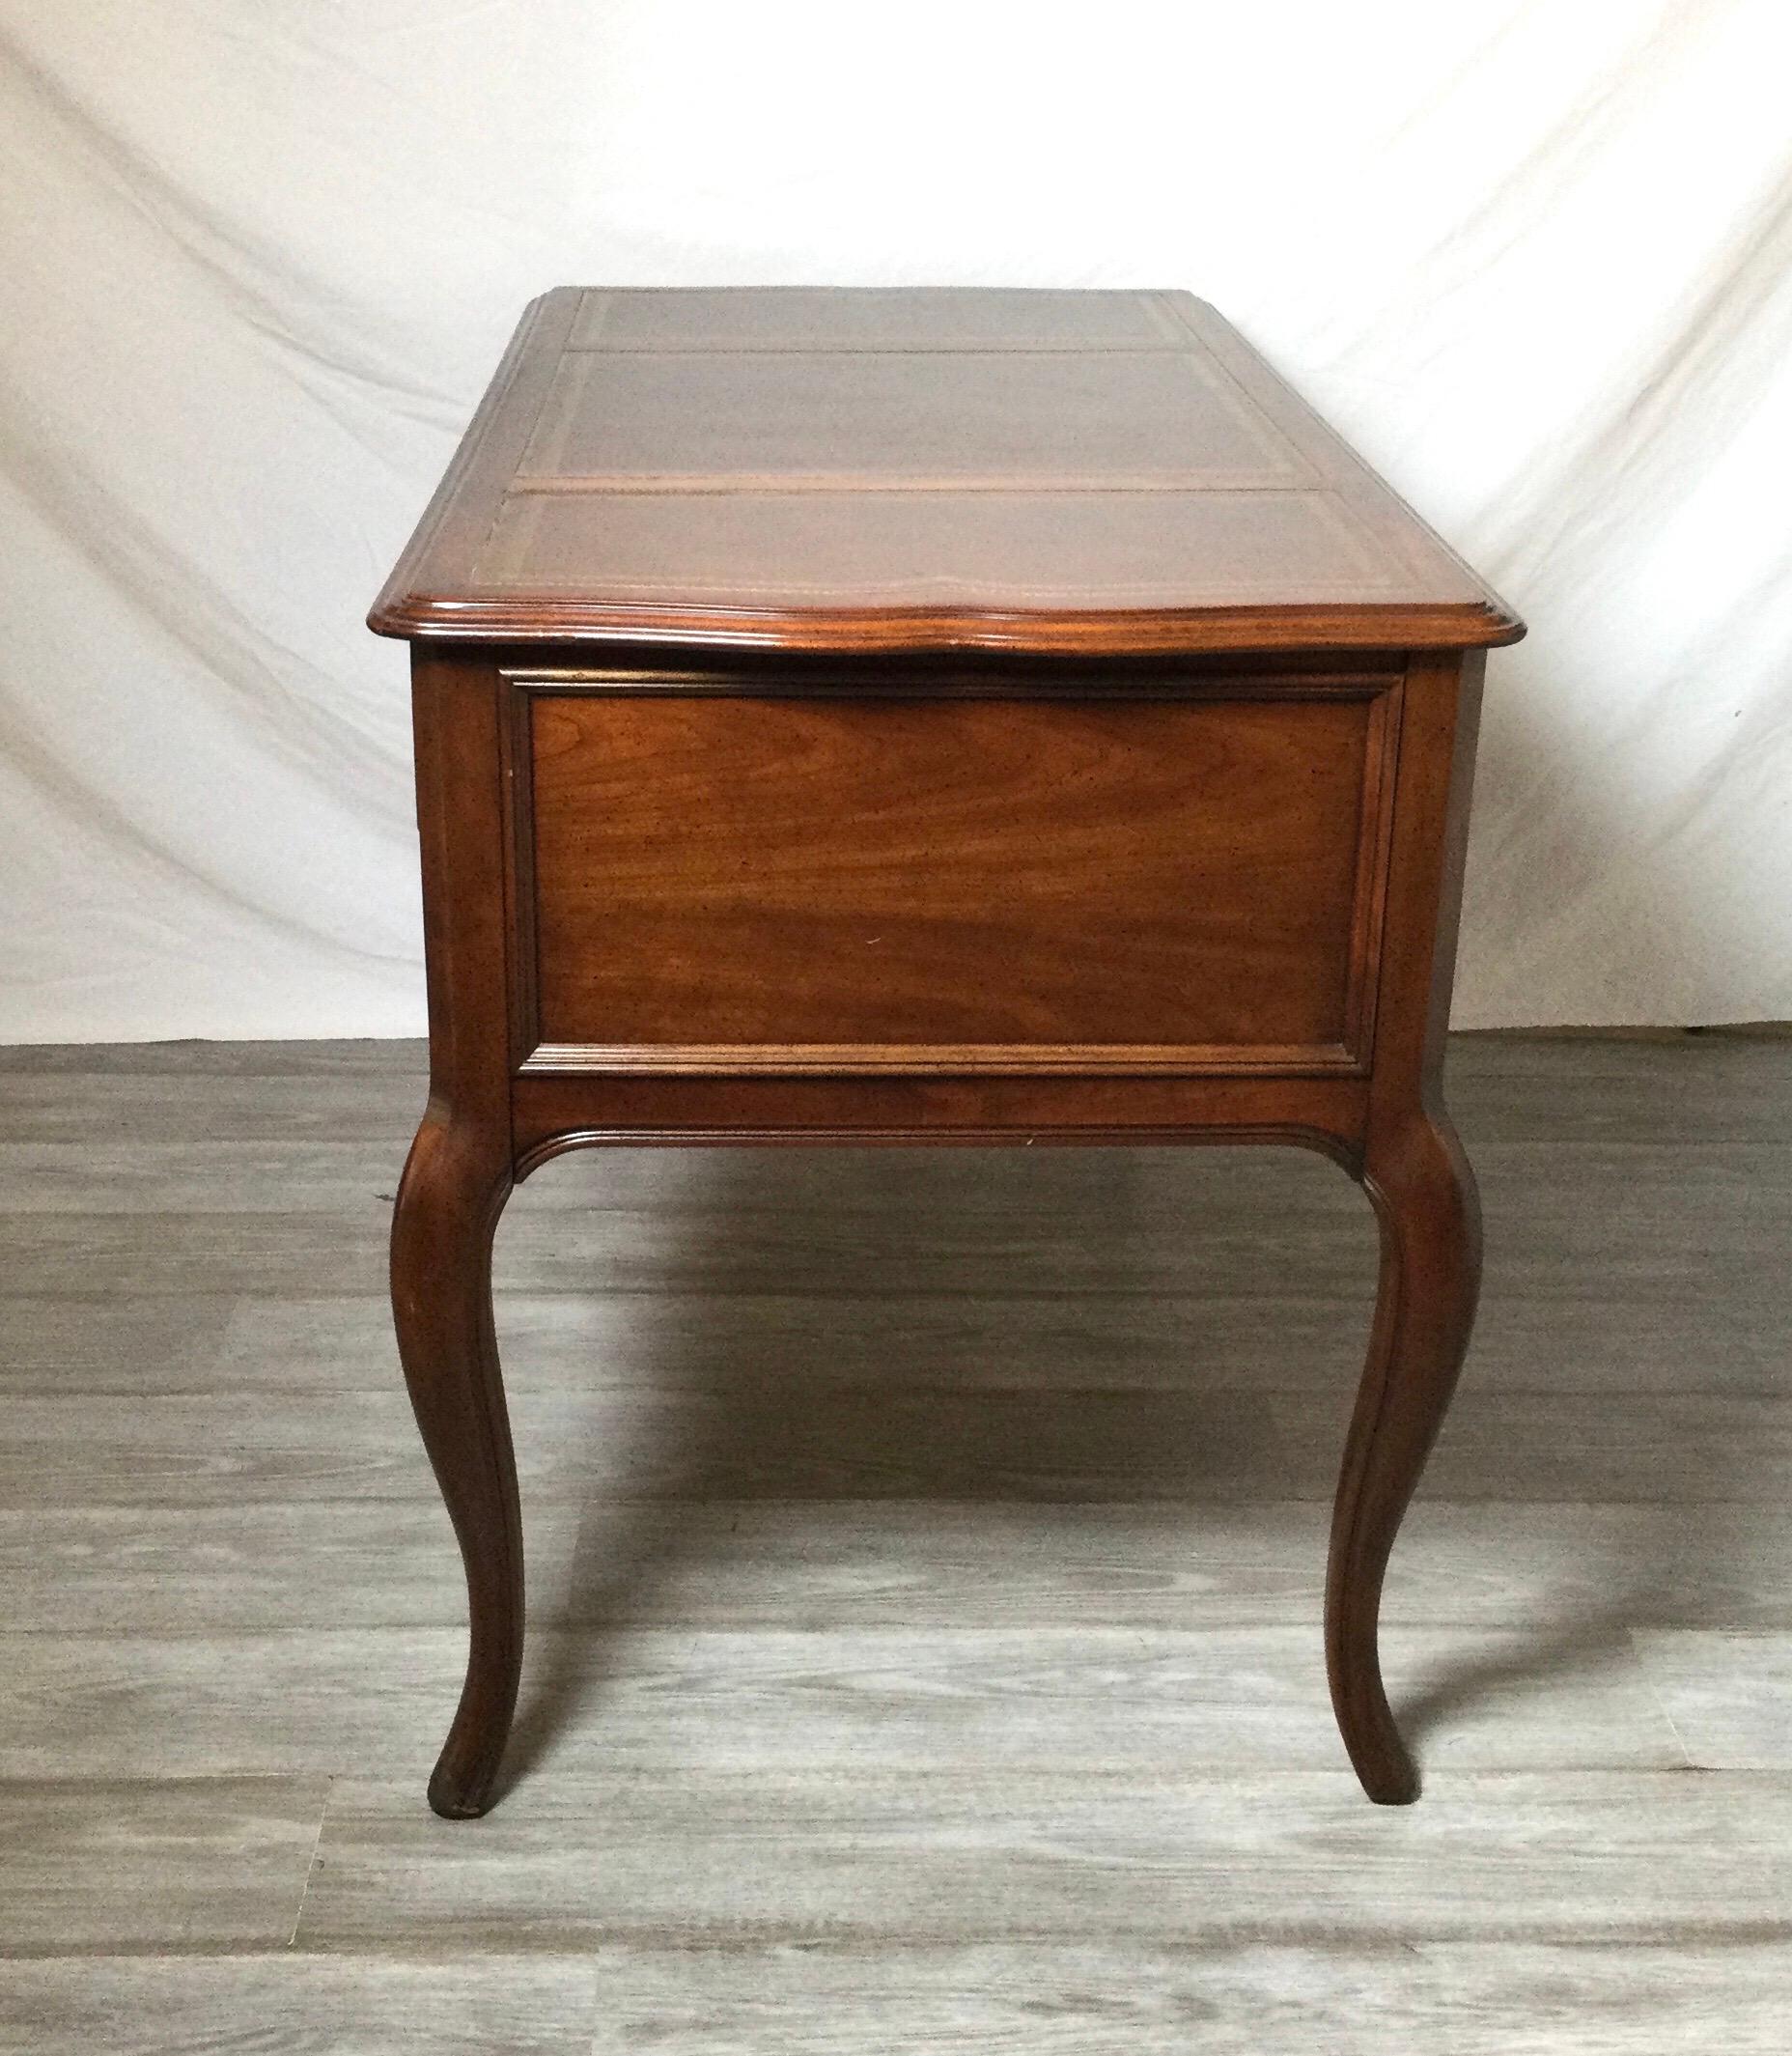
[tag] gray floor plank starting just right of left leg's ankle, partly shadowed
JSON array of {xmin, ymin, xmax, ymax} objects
[{"xmin": 572, "ymin": 1497, "xmax": 1792, "ymax": 1641}]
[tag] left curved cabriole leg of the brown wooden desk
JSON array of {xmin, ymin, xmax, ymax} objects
[{"xmin": 393, "ymin": 1109, "xmax": 511, "ymax": 1819}]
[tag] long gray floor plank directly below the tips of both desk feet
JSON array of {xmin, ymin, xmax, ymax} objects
[{"xmin": 300, "ymin": 1762, "xmax": 1792, "ymax": 1949}]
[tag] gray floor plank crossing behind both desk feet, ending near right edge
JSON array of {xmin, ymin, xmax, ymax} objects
[{"xmin": 0, "ymin": 1622, "xmax": 1685, "ymax": 1779}]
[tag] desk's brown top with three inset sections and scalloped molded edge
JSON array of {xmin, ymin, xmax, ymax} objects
[{"xmin": 370, "ymin": 288, "xmax": 1523, "ymax": 654}]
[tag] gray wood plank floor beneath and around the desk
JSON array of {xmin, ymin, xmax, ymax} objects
[{"xmin": 0, "ymin": 1034, "xmax": 1792, "ymax": 2056}]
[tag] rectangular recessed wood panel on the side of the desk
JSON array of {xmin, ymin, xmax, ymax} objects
[{"xmin": 518, "ymin": 687, "xmax": 1389, "ymax": 1071}]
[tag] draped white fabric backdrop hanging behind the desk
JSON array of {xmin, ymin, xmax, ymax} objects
[{"xmin": 0, "ymin": 0, "xmax": 1792, "ymax": 1040}]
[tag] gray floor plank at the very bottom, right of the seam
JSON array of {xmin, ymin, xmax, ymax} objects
[{"xmin": 571, "ymin": 1941, "xmax": 1792, "ymax": 2056}]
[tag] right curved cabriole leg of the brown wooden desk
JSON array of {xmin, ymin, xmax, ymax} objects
[{"xmin": 1326, "ymin": 1112, "xmax": 1482, "ymax": 1805}]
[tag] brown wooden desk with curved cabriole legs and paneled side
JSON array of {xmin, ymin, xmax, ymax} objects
[{"xmin": 370, "ymin": 288, "xmax": 1523, "ymax": 1816}]
